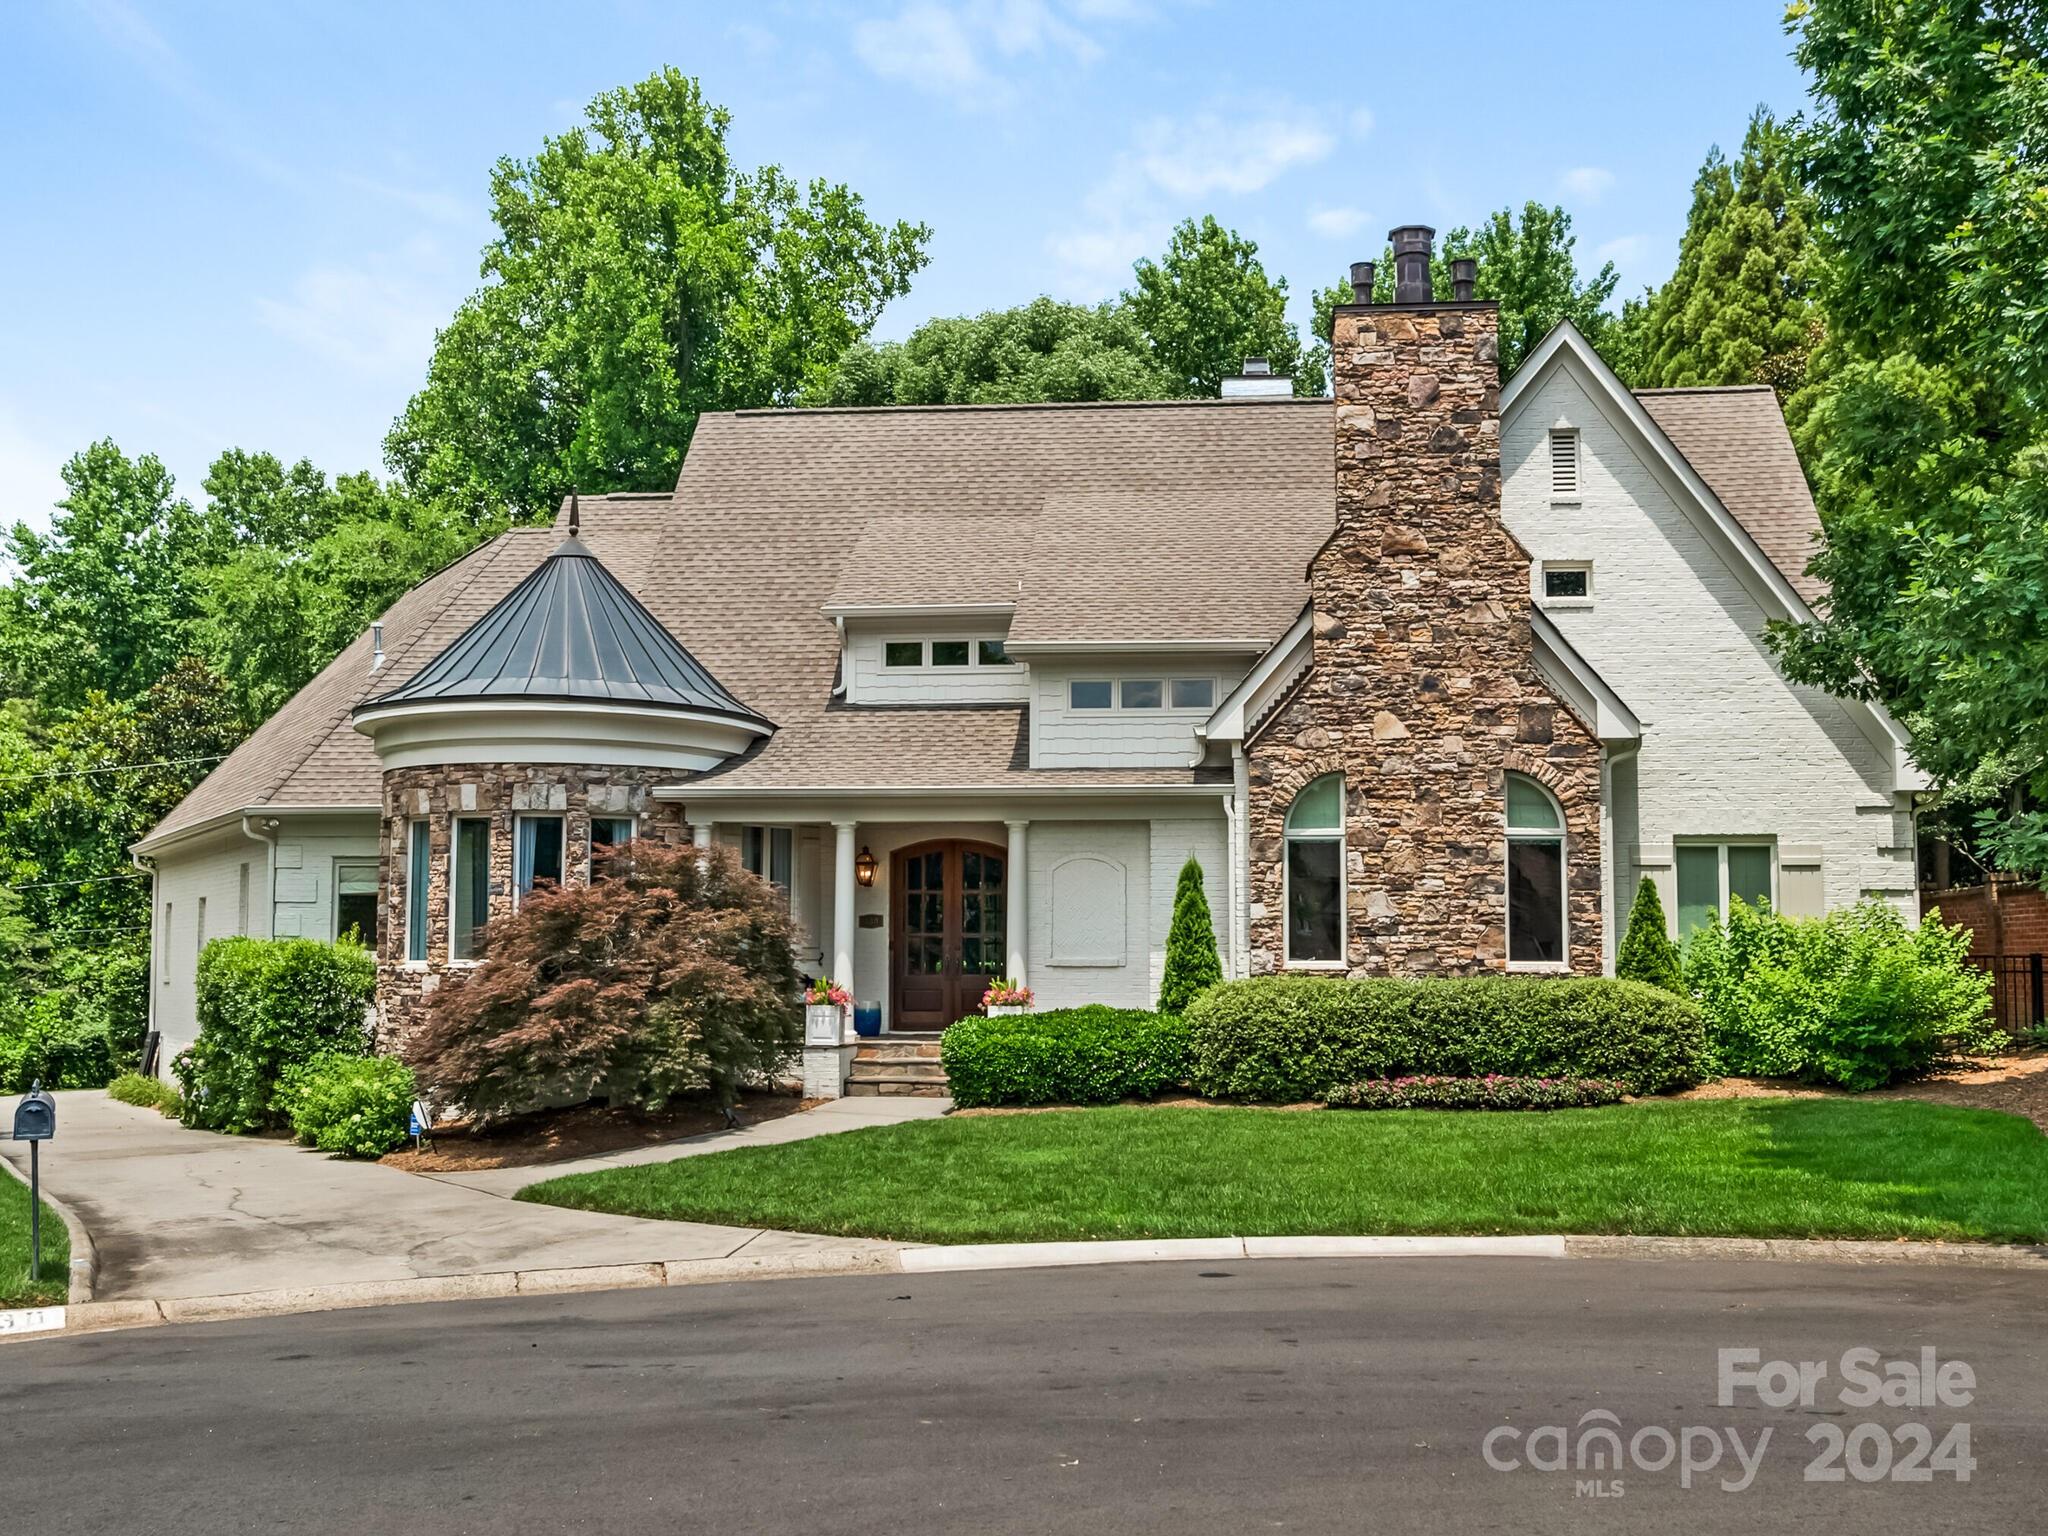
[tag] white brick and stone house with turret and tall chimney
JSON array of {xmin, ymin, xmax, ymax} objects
[{"xmin": 137, "ymin": 229, "xmax": 1921, "ymax": 1094}]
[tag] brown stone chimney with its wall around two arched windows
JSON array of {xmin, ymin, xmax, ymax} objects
[{"xmin": 1247, "ymin": 303, "xmax": 1602, "ymax": 975}]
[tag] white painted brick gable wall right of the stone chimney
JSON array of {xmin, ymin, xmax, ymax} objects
[{"xmin": 1501, "ymin": 369, "xmax": 1917, "ymax": 915}]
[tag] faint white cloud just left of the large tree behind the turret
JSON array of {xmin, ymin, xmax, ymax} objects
[{"xmin": 256, "ymin": 240, "xmax": 453, "ymax": 383}]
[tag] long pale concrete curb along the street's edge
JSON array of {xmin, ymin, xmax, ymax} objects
[{"xmin": 0, "ymin": 1235, "xmax": 2048, "ymax": 1341}]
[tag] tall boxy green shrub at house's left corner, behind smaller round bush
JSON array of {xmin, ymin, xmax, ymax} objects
[{"xmin": 172, "ymin": 938, "xmax": 377, "ymax": 1133}]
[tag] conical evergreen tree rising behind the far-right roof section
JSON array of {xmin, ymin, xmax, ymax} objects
[{"xmin": 1624, "ymin": 106, "xmax": 1819, "ymax": 399}]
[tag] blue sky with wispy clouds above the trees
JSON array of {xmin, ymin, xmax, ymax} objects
[{"xmin": 0, "ymin": 0, "xmax": 1804, "ymax": 540}]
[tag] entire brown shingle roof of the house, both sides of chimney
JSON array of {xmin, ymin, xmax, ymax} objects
[{"xmin": 150, "ymin": 389, "xmax": 1819, "ymax": 842}]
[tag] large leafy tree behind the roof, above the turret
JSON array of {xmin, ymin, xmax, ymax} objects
[{"xmin": 385, "ymin": 70, "xmax": 930, "ymax": 520}]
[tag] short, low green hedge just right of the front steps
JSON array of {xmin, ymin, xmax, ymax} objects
[{"xmin": 940, "ymin": 1004, "xmax": 1188, "ymax": 1108}]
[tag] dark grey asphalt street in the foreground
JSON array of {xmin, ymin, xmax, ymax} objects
[{"xmin": 0, "ymin": 1260, "xmax": 2048, "ymax": 1536}]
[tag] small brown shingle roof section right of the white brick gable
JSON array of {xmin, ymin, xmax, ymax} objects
[{"xmin": 1636, "ymin": 385, "xmax": 1827, "ymax": 602}]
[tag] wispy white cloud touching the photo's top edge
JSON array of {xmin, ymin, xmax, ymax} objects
[{"xmin": 854, "ymin": 0, "xmax": 1139, "ymax": 111}]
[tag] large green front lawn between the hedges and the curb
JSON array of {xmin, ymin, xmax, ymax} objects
[{"xmin": 518, "ymin": 1100, "xmax": 2048, "ymax": 1243}]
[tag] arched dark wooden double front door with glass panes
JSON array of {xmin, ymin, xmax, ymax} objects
[{"xmin": 889, "ymin": 842, "xmax": 1010, "ymax": 1030}]
